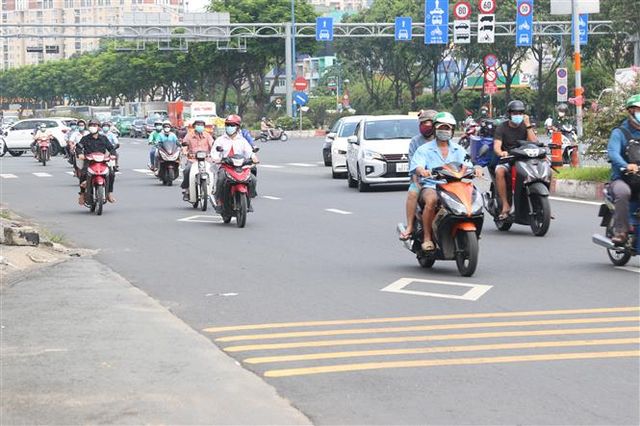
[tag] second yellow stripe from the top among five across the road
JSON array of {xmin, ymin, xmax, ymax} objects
[{"xmin": 215, "ymin": 316, "xmax": 640, "ymax": 342}]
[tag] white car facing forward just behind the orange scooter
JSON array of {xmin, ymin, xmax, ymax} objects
[{"xmin": 347, "ymin": 115, "xmax": 419, "ymax": 192}]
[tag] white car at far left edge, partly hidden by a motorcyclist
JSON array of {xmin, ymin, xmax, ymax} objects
[{"xmin": 0, "ymin": 118, "xmax": 69, "ymax": 157}]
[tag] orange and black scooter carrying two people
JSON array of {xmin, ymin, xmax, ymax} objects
[{"xmin": 397, "ymin": 163, "xmax": 484, "ymax": 277}]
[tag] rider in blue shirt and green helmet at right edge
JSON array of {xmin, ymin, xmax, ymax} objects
[{"xmin": 607, "ymin": 93, "xmax": 640, "ymax": 245}]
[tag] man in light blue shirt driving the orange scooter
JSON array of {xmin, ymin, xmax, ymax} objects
[{"xmin": 409, "ymin": 112, "xmax": 482, "ymax": 252}]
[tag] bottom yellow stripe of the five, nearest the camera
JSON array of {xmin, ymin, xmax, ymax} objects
[{"xmin": 264, "ymin": 350, "xmax": 640, "ymax": 377}]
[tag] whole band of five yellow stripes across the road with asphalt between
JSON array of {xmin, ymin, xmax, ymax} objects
[{"xmin": 203, "ymin": 306, "xmax": 640, "ymax": 378}]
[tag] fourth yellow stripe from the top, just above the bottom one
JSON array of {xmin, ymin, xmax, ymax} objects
[{"xmin": 244, "ymin": 338, "xmax": 640, "ymax": 364}]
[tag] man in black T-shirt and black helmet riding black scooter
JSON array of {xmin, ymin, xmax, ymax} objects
[{"xmin": 493, "ymin": 100, "xmax": 537, "ymax": 220}]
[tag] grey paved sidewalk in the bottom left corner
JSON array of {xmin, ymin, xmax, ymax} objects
[{"xmin": 0, "ymin": 258, "xmax": 310, "ymax": 425}]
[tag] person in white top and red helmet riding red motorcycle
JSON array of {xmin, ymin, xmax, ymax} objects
[{"xmin": 211, "ymin": 114, "xmax": 258, "ymax": 212}]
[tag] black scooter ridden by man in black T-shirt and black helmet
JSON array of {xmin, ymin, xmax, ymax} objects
[{"xmin": 484, "ymin": 141, "xmax": 551, "ymax": 237}]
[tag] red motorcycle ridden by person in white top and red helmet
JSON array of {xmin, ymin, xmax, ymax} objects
[{"xmin": 217, "ymin": 146, "xmax": 258, "ymax": 228}]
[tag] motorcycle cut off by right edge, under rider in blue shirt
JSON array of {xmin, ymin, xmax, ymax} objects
[{"xmin": 591, "ymin": 171, "xmax": 640, "ymax": 266}]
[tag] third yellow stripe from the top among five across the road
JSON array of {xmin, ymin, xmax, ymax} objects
[{"xmin": 224, "ymin": 327, "xmax": 640, "ymax": 352}]
